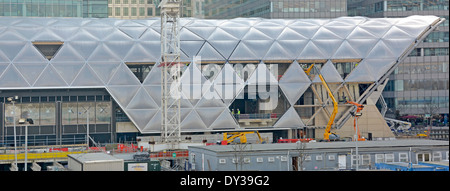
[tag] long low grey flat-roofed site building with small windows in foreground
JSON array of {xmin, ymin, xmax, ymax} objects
[{"xmin": 189, "ymin": 140, "xmax": 449, "ymax": 171}]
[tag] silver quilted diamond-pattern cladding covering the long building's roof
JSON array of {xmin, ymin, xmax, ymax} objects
[{"xmin": 0, "ymin": 16, "xmax": 439, "ymax": 133}]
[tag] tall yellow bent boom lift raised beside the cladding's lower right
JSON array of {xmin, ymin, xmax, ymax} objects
[{"xmin": 305, "ymin": 64, "xmax": 340, "ymax": 141}]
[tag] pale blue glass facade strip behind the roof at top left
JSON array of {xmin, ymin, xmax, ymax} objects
[{"xmin": 0, "ymin": 0, "xmax": 108, "ymax": 18}]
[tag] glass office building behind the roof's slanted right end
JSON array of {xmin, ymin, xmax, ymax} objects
[{"xmin": 348, "ymin": 0, "xmax": 449, "ymax": 119}]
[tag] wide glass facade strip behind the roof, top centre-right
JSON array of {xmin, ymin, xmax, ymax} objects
[{"xmin": 203, "ymin": 0, "xmax": 347, "ymax": 19}]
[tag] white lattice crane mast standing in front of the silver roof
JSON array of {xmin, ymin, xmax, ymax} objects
[{"xmin": 159, "ymin": 0, "xmax": 181, "ymax": 143}]
